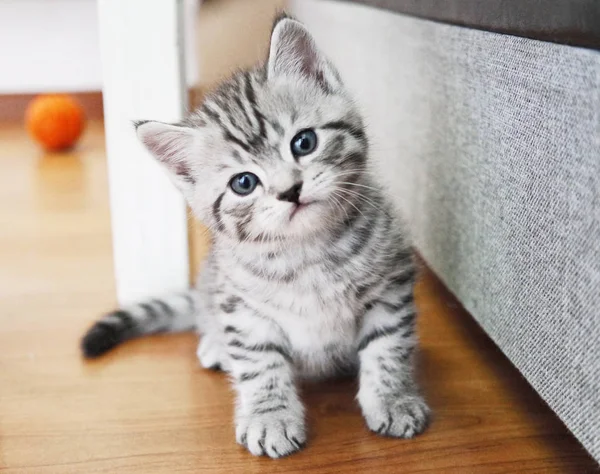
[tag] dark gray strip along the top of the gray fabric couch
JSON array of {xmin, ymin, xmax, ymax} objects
[{"xmin": 339, "ymin": 0, "xmax": 600, "ymax": 50}]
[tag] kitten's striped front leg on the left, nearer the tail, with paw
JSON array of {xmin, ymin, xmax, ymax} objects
[{"xmin": 221, "ymin": 297, "xmax": 306, "ymax": 458}]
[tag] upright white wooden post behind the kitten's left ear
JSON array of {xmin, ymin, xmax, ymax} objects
[{"xmin": 98, "ymin": 0, "xmax": 189, "ymax": 304}]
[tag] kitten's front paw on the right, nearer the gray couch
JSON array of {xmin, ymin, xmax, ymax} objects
[{"xmin": 364, "ymin": 395, "xmax": 431, "ymax": 438}]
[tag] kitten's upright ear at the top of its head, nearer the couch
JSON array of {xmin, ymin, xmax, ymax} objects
[{"xmin": 267, "ymin": 16, "xmax": 341, "ymax": 92}]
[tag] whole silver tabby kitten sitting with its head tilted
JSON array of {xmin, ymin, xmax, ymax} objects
[{"xmin": 83, "ymin": 16, "xmax": 429, "ymax": 458}]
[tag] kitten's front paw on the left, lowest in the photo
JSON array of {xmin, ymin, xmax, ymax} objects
[{"xmin": 235, "ymin": 410, "xmax": 306, "ymax": 458}]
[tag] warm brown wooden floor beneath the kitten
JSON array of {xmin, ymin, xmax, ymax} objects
[{"xmin": 0, "ymin": 123, "xmax": 596, "ymax": 474}]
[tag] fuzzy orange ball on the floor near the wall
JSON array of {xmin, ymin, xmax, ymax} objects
[{"xmin": 25, "ymin": 94, "xmax": 85, "ymax": 151}]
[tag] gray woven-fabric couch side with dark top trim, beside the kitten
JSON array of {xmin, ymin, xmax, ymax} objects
[{"xmin": 294, "ymin": 0, "xmax": 600, "ymax": 460}]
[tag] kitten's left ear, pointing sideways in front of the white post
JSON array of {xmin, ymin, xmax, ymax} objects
[{"xmin": 134, "ymin": 121, "xmax": 197, "ymax": 189}]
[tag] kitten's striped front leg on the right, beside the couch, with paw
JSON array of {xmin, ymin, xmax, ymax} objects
[{"xmin": 357, "ymin": 280, "xmax": 430, "ymax": 438}]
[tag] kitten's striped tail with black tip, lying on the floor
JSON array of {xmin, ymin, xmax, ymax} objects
[{"xmin": 81, "ymin": 289, "xmax": 199, "ymax": 359}]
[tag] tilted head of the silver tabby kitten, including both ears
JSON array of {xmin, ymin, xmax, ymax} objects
[{"xmin": 137, "ymin": 13, "xmax": 367, "ymax": 241}]
